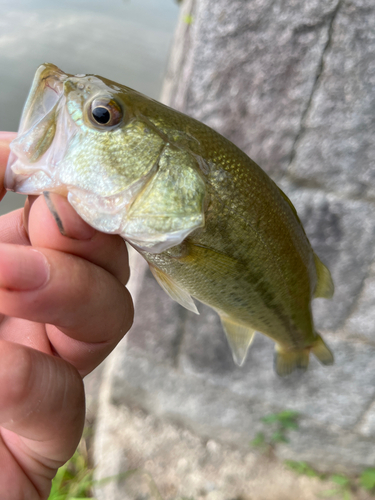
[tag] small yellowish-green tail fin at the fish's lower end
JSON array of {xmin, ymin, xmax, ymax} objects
[{"xmin": 275, "ymin": 334, "xmax": 334, "ymax": 377}]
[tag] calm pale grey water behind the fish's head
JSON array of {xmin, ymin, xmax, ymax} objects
[{"xmin": 0, "ymin": 0, "xmax": 179, "ymax": 214}]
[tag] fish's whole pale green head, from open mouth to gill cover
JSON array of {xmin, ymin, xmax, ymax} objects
[{"xmin": 5, "ymin": 64, "xmax": 205, "ymax": 253}]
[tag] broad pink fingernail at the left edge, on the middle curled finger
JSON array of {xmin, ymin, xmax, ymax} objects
[{"xmin": 0, "ymin": 243, "xmax": 50, "ymax": 290}]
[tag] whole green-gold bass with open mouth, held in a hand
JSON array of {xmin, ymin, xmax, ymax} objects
[{"xmin": 5, "ymin": 63, "xmax": 334, "ymax": 376}]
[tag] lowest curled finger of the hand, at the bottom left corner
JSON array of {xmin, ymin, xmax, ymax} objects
[{"xmin": 0, "ymin": 341, "xmax": 85, "ymax": 498}]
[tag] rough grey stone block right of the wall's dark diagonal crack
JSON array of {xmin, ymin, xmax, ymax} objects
[{"xmin": 290, "ymin": 0, "xmax": 375, "ymax": 201}]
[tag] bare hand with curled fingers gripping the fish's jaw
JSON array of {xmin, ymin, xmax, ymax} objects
[{"xmin": 0, "ymin": 132, "xmax": 133, "ymax": 500}]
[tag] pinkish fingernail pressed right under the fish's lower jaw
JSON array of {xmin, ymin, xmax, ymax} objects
[{"xmin": 43, "ymin": 191, "xmax": 97, "ymax": 240}]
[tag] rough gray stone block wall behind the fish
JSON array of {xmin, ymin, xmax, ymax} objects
[{"xmin": 93, "ymin": 0, "xmax": 375, "ymax": 492}]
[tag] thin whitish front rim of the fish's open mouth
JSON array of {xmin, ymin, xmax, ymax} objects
[{"xmin": 4, "ymin": 63, "xmax": 71, "ymax": 193}]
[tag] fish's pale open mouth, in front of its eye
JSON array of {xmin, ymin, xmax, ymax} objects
[{"xmin": 4, "ymin": 64, "xmax": 72, "ymax": 193}]
